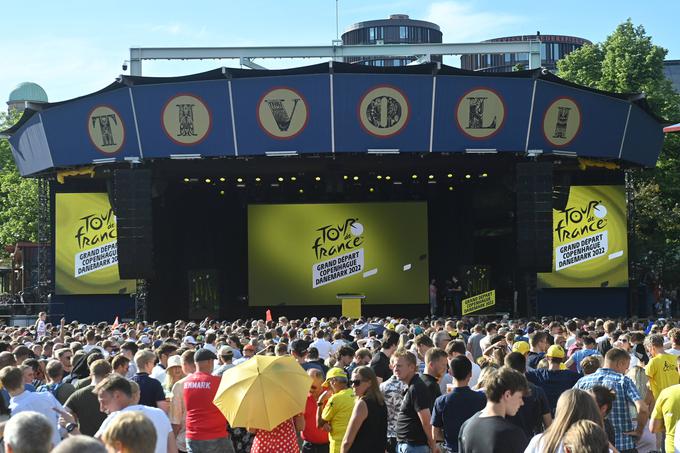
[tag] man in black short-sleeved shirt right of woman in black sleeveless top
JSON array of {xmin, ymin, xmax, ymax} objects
[{"xmin": 394, "ymin": 349, "xmax": 439, "ymax": 453}]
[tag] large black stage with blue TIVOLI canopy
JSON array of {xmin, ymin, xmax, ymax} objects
[{"xmin": 5, "ymin": 63, "xmax": 663, "ymax": 320}]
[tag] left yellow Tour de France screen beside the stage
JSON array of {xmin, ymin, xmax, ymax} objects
[{"xmin": 55, "ymin": 193, "xmax": 135, "ymax": 294}]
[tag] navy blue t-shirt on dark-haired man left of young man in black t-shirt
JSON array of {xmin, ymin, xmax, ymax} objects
[{"xmin": 431, "ymin": 386, "xmax": 486, "ymax": 452}]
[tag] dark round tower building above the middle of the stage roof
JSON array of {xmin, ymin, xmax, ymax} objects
[{"xmin": 342, "ymin": 14, "xmax": 442, "ymax": 66}]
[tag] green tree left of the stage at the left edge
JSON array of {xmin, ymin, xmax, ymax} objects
[{"xmin": 0, "ymin": 111, "xmax": 38, "ymax": 251}]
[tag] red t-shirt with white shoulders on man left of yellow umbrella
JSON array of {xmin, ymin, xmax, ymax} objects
[{"xmin": 183, "ymin": 371, "xmax": 228, "ymax": 440}]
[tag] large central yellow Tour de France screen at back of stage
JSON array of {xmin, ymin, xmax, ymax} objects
[{"xmin": 248, "ymin": 202, "xmax": 428, "ymax": 306}]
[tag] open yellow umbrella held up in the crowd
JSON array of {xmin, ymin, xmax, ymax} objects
[{"xmin": 213, "ymin": 355, "xmax": 312, "ymax": 431}]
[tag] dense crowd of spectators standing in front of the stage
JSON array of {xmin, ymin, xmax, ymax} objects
[{"xmin": 0, "ymin": 314, "xmax": 680, "ymax": 453}]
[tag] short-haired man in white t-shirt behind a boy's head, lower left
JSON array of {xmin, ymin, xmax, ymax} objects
[{"xmin": 94, "ymin": 374, "xmax": 177, "ymax": 453}]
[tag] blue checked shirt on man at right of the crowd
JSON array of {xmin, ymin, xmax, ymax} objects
[{"xmin": 574, "ymin": 368, "xmax": 642, "ymax": 451}]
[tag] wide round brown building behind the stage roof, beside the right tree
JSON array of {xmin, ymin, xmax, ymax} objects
[{"xmin": 460, "ymin": 33, "xmax": 592, "ymax": 72}]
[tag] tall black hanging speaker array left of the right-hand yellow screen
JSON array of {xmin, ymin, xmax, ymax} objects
[{"xmin": 516, "ymin": 162, "xmax": 553, "ymax": 272}]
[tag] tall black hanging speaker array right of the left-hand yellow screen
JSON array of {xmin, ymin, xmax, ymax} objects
[{"xmin": 113, "ymin": 169, "xmax": 153, "ymax": 279}]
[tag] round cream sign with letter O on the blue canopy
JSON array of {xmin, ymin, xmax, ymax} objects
[{"xmin": 359, "ymin": 85, "xmax": 410, "ymax": 138}]
